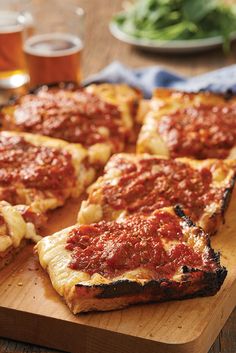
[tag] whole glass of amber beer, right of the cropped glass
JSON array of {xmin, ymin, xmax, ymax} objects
[{"xmin": 23, "ymin": 0, "xmax": 84, "ymax": 87}]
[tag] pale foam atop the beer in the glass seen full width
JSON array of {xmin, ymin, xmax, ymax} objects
[{"xmin": 24, "ymin": 33, "xmax": 83, "ymax": 57}]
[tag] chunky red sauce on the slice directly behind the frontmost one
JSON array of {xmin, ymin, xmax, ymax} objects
[{"xmin": 103, "ymin": 157, "xmax": 223, "ymax": 221}]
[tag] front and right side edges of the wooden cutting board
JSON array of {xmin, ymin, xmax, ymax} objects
[{"xmin": 0, "ymin": 288, "xmax": 236, "ymax": 353}]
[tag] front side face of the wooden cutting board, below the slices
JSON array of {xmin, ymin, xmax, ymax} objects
[{"xmin": 0, "ymin": 307, "xmax": 214, "ymax": 353}]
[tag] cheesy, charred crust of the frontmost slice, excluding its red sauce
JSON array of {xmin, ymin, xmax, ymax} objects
[{"xmin": 36, "ymin": 206, "xmax": 227, "ymax": 314}]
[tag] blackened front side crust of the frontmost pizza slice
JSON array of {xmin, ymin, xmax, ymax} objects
[{"xmin": 67, "ymin": 269, "xmax": 226, "ymax": 313}]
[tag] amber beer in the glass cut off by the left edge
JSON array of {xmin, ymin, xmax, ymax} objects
[{"xmin": 0, "ymin": 11, "xmax": 25, "ymax": 80}]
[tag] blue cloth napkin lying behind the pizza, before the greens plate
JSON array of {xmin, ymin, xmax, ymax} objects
[{"xmin": 84, "ymin": 61, "xmax": 236, "ymax": 98}]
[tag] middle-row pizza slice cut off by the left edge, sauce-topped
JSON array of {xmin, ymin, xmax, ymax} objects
[{"xmin": 0, "ymin": 131, "xmax": 95, "ymax": 213}]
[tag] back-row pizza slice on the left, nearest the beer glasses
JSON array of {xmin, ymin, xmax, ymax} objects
[{"xmin": 1, "ymin": 84, "xmax": 140, "ymax": 165}]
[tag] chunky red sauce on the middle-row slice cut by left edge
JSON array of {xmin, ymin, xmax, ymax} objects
[{"xmin": 0, "ymin": 134, "xmax": 76, "ymax": 190}]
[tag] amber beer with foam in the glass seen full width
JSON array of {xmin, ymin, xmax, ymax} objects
[{"xmin": 24, "ymin": 33, "xmax": 83, "ymax": 86}]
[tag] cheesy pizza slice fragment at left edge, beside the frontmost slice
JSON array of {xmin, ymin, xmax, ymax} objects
[{"xmin": 0, "ymin": 201, "xmax": 41, "ymax": 269}]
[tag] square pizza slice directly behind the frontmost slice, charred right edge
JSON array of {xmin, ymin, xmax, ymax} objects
[{"xmin": 78, "ymin": 153, "xmax": 236, "ymax": 234}]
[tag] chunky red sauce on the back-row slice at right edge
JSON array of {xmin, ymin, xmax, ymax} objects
[{"xmin": 158, "ymin": 104, "xmax": 236, "ymax": 159}]
